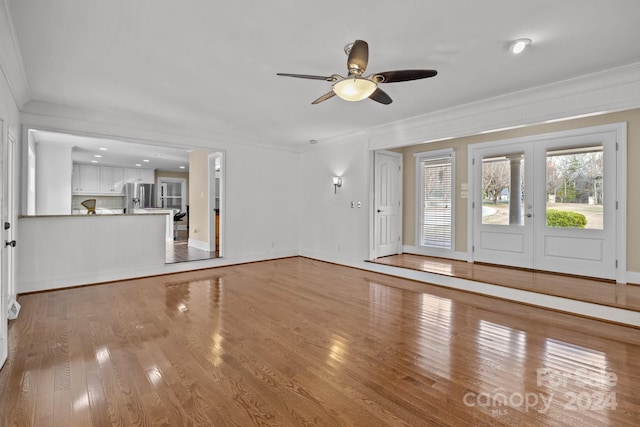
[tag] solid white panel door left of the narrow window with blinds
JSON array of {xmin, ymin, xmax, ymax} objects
[{"xmin": 374, "ymin": 151, "xmax": 402, "ymax": 257}]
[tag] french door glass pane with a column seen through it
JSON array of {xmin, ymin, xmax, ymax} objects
[{"xmin": 482, "ymin": 153, "xmax": 525, "ymax": 226}]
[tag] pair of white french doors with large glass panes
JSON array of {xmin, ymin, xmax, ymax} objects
[{"xmin": 470, "ymin": 127, "xmax": 618, "ymax": 279}]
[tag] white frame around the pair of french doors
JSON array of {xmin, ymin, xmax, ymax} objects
[{"xmin": 467, "ymin": 122, "xmax": 627, "ymax": 283}]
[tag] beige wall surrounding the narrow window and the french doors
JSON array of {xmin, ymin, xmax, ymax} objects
[{"xmin": 403, "ymin": 109, "xmax": 640, "ymax": 272}]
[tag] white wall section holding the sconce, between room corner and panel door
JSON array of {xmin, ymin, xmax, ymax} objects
[{"xmin": 298, "ymin": 139, "xmax": 371, "ymax": 266}]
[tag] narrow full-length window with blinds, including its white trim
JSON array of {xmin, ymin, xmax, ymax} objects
[{"xmin": 416, "ymin": 149, "xmax": 455, "ymax": 250}]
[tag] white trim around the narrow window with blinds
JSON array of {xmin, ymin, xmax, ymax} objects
[{"xmin": 414, "ymin": 148, "xmax": 457, "ymax": 254}]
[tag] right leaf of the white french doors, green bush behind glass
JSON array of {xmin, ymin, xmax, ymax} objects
[{"xmin": 535, "ymin": 132, "xmax": 617, "ymax": 279}]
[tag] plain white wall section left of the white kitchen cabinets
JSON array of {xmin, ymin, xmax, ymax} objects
[{"xmin": 35, "ymin": 144, "xmax": 73, "ymax": 215}]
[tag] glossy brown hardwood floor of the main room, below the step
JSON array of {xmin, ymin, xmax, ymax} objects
[{"xmin": 0, "ymin": 258, "xmax": 640, "ymax": 426}]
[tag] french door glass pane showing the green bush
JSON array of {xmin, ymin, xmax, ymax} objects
[{"xmin": 546, "ymin": 145, "xmax": 604, "ymax": 230}]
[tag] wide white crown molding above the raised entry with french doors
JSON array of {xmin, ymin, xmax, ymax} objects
[{"xmin": 367, "ymin": 63, "xmax": 640, "ymax": 149}]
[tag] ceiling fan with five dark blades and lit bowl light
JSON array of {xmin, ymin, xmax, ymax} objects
[{"xmin": 277, "ymin": 40, "xmax": 438, "ymax": 105}]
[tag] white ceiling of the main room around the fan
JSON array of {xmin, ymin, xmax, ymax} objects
[{"xmin": 8, "ymin": 0, "xmax": 640, "ymax": 149}]
